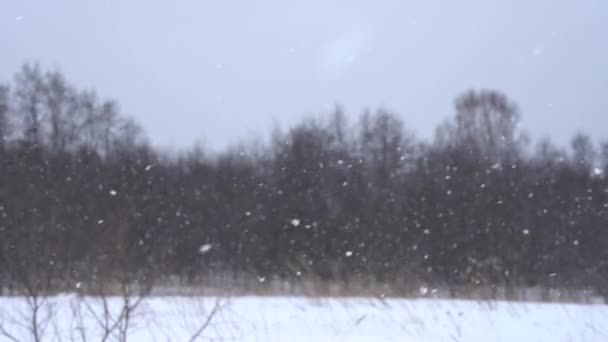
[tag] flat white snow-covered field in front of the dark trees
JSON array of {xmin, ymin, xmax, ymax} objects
[{"xmin": 0, "ymin": 296, "xmax": 608, "ymax": 342}]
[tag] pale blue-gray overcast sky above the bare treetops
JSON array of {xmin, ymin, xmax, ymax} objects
[{"xmin": 0, "ymin": 0, "xmax": 608, "ymax": 148}]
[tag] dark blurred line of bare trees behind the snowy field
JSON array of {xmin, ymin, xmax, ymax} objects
[{"xmin": 0, "ymin": 64, "xmax": 608, "ymax": 295}]
